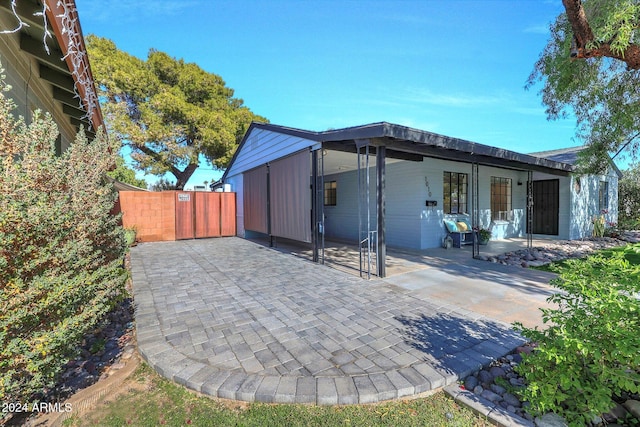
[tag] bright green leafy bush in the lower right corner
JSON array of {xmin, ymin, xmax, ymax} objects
[{"xmin": 516, "ymin": 245, "xmax": 640, "ymax": 425}]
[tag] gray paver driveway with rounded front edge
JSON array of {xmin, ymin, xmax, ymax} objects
[{"xmin": 132, "ymin": 238, "xmax": 522, "ymax": 404}]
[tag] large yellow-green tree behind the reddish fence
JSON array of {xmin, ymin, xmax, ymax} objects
[{"xmin": 86, "ymin": 36, "xmax": 266, "ymax": 189}]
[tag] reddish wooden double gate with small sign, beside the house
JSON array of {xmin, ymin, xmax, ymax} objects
[{"xmin": 176, "ymin": 191, "xmax": 236, "ymax": 240}]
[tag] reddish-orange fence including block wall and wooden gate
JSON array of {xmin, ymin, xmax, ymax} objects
[{"xmin": 119, "ymin": 191, "xmax": 236, "ymax": 242}]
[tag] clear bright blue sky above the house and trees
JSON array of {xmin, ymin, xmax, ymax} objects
[{"xmin": 76, "ymin": 0, "xmax": 578, "ymax": 186}]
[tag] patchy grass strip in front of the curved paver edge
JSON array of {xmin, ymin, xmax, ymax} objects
[{"xmin": 64, "ymin": 364, "xmax": 490, "ymax": 427}]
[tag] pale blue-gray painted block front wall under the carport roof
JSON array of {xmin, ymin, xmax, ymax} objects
[{"xmin": 324, "ymin": 158, "xmax": 526, "ymax": 249}]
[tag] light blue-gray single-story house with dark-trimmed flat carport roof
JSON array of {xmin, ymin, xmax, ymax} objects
[{"xmin": 222, "ymin": 123, "xmax": 618, "ymax": 276}]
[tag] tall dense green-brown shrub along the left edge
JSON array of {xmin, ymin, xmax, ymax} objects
[{"xmin": 0, "ymin": 80, "xmax": 126, "ymax": 403}]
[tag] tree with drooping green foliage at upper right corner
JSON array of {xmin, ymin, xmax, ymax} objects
[{"xmin": 527, "ymin": 0, "xmax": 640, "ymax": 172}]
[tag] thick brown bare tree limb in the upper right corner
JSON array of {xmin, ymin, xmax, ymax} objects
[{"xmin": 562, "ymin": 0, "xmax": 640, "ymax": 70}]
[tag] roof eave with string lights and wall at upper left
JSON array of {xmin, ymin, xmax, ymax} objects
[{"xmin": 0, "ymin": 0, "xmax": 102, "ymax": 153}]
